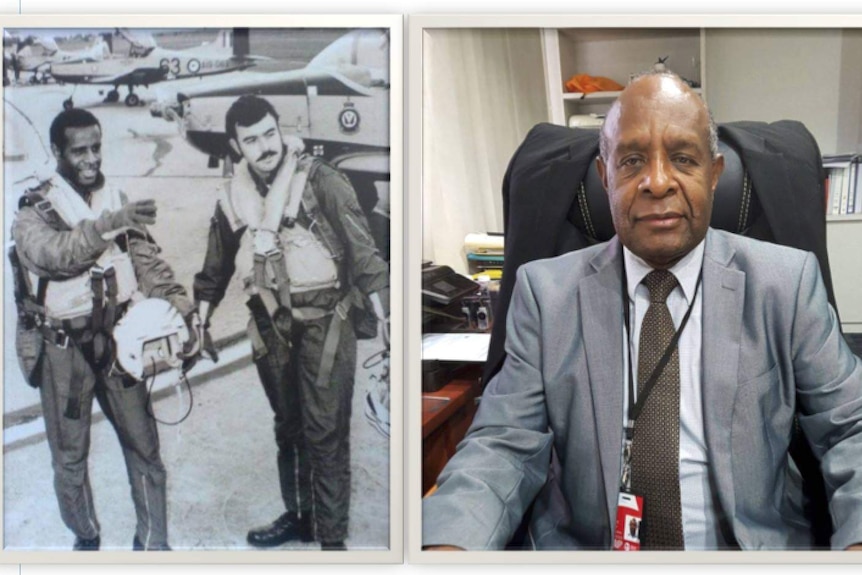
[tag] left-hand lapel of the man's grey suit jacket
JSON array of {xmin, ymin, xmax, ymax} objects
[{"xmin": 579, "ymin": 238, "xmax": 623, "ymax": 525}]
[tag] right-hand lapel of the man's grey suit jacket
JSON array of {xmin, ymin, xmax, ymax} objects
[{"xmin": 701, "ymin": 230, "xmax": 745, "ymax": 517}]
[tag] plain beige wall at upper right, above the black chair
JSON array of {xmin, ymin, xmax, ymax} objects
[{"xmin": 705, "ymin": 28, "xmax": 860, "ymax": 154}]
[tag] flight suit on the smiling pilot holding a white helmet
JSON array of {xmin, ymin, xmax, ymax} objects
[{"xmin": 12, "ymin": 175, "xmax": 194, "ymax": 548}]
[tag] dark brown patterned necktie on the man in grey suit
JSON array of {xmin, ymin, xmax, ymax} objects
[{"xmin": 632, "ymin": 270, "xmax": 685, "ymax": 550}]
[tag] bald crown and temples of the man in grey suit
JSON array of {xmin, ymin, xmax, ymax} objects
[{"xmin": 599, "ymin": 72, "xmax": 718, "ymax": 161}]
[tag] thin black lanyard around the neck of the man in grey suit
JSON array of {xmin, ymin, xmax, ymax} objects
[{"xmin": 620, "ymin": 262, "xmax": 703, "ymax": 491}]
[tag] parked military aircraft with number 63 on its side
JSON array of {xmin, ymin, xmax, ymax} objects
[{"xmin": 51, "ymin": 29, "xmax": 268, "ymax": 108}]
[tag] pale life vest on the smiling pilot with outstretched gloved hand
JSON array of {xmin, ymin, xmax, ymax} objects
[{"xmin": 19, "ymin": 175, "xmax": 138, "ymax": 320}]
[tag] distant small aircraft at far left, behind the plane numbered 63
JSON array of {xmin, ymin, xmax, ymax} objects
[{"xmin": 11, "ymin": 34, "xmax": 111, "ymax": 84}]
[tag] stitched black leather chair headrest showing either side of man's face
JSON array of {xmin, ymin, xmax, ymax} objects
[{"xmin": 568, "ymin": 141, "xmax": 761, "ymax": 242}]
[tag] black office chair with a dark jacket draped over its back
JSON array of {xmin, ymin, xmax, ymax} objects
[{"xmin": 492, "ymin": 120, "xmax": 837, "ymax": 549}]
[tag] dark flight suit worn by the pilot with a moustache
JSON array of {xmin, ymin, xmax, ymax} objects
[{"xmin": 194, "ymin": 157, "xmax": 389, "ymax": 542}]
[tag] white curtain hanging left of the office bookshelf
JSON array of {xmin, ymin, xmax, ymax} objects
[{"xmin": 424, "ymin": 29, "xmax": 548, "ymax": 273}]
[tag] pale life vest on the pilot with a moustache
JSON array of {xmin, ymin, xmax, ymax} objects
[{"xmin": 219, "ymin": 156, "xmax": 340, "ymax": 296}]
